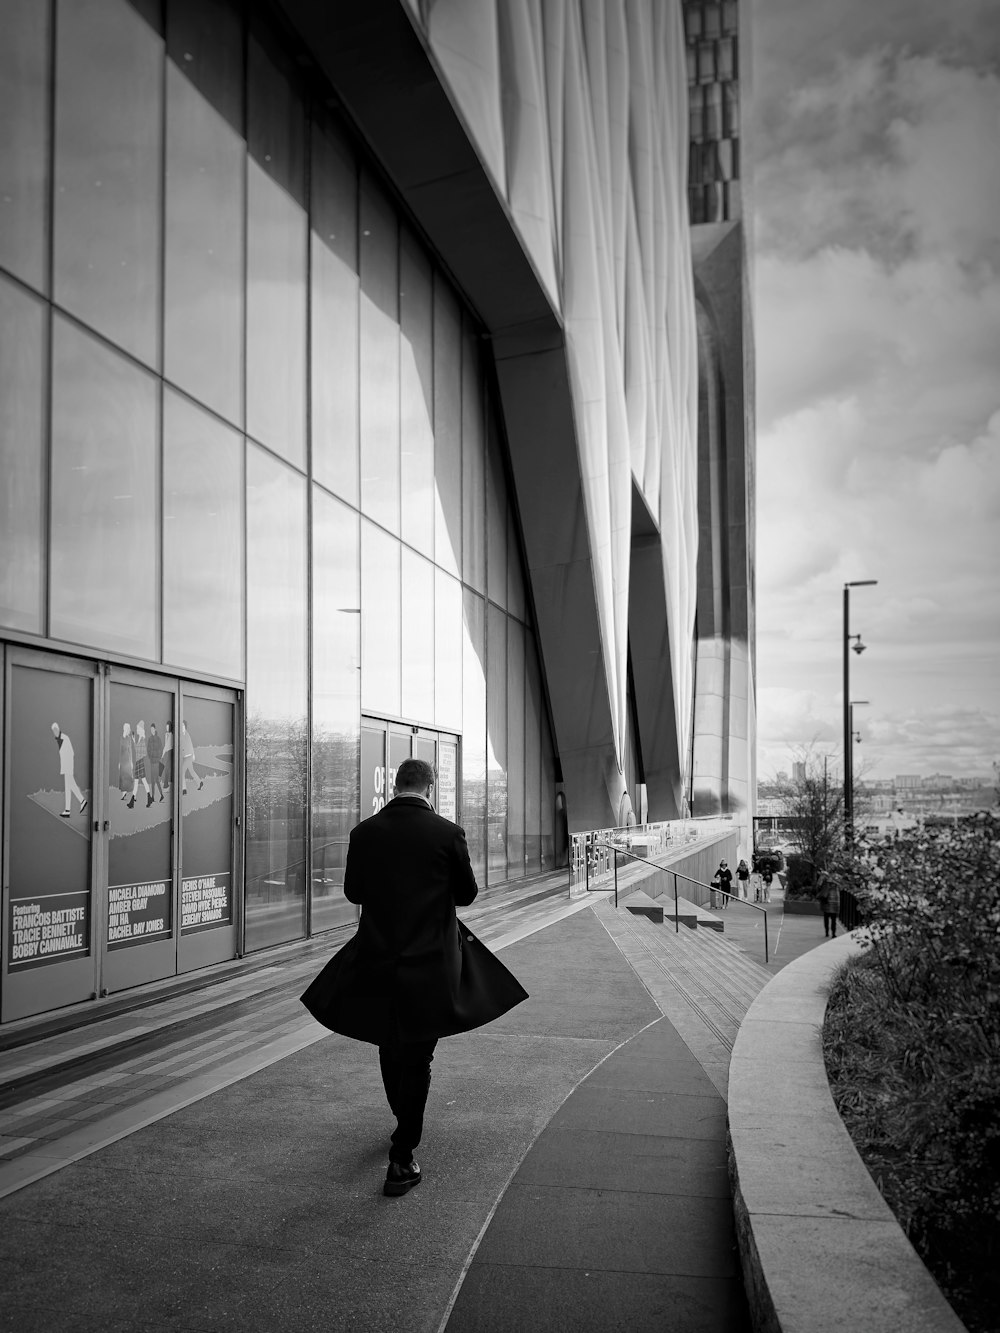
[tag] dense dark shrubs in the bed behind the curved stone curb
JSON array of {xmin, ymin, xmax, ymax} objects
[{"xmin": 824, "ymin": 816, "xmax": 1000, "ymax": 1330}]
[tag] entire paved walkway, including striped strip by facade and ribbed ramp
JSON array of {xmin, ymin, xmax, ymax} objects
[{"xmin": 0, "ymin": 880, "xmax": 815, "ymax": 1333}]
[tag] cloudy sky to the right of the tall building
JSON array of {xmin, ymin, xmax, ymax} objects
[{"xmin": 744, "ymin": 0, "xmax": 1000, "ymax": 781}]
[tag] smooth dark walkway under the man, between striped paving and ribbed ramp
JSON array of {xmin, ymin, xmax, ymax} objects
[{"xmin": 0, "ymin": 908, "xmax": 762, "ymax": 1333}]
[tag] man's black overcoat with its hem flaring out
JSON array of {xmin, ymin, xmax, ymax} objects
[{"xmin": 303, "ymin": 797, "xmax": 527, "ymax": 1045}]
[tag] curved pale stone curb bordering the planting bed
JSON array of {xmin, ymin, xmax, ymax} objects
[{"xmin": 728, "ymin": 934, "xmax": 965, "ymax": 1333}]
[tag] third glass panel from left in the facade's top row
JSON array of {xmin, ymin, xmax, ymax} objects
[{"xmin": 164, "ymin": 0, "xmax": 245, "ymax": 425}]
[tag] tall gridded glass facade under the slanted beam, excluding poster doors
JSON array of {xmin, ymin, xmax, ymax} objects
[{"xmin": 0, "ymin": 0, "xmax": 565, "ymax": 1002}]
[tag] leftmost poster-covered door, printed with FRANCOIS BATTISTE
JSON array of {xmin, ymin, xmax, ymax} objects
[{"xmin": 1, "ymin": 648, "xmax": 100, "ymax": 1022}]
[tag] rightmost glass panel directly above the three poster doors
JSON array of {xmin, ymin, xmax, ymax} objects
[{"xmin": 163, "ymin": 389, "xmax": 243, "ymax": 680}]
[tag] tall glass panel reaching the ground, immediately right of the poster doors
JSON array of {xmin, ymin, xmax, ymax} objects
[{"xmin": 247, "ymin": 445, "xmax": 307, "ymax": 949}]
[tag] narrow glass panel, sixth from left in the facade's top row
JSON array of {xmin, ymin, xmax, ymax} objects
[{"xmin": 360, "ymin": 175, "xmax": 399, "ymax": 532}]
